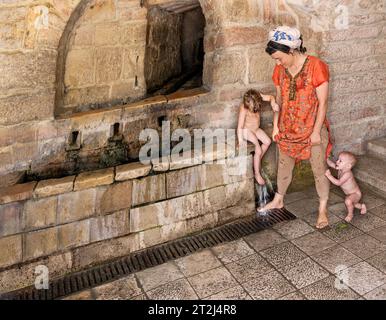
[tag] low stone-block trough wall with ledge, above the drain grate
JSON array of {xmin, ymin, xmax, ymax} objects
[{"xmin": 0, "ymin": 149, "xmax": 255, "ymax": 293}]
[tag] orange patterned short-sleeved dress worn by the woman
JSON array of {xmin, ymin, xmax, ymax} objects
[{"xmin": 272, "ymin": 56, "xmax": 332, "ymax": 162}]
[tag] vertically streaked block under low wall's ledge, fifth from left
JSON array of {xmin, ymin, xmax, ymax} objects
[{"xmin": 132, "ymin": 174, "xmax": 166, "ymax": 206}]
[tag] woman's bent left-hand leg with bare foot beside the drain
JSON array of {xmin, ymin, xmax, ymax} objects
[{"xmin": 261, "ymin": 150, "xmax": 295, "ymax": 211}]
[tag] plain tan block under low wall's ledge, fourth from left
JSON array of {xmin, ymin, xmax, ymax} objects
[{"xmin": 95, "ymin": 181, "xmax": 133, "ymax": 213}]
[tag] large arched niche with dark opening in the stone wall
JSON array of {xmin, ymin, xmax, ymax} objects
[{"xmin": 55, "ymin": 0, "xmax": 205, "ymax": 116}]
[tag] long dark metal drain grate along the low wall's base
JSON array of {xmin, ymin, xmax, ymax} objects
[{"xmin": 0, "ymin": 209, "xmax": 296, "ymax": 300}]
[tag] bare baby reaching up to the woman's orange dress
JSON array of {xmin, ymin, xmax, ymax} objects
[{"xmin": 326, "ymin": 152, "xmax": 367, "ymax": 222}]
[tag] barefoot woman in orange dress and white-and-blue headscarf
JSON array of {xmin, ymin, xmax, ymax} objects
[{"xmin": 262, "ymin": 26, "xmax": 332, "ymax": 229}]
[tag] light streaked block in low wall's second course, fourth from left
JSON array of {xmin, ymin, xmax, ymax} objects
[{"xmin": 90, "ymin": 210, "xmax": 129, "ymax": 242}]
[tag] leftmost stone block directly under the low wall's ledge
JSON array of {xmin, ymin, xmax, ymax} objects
[{"xmin": 0, "ymin": 202, "xmax": 23, "ymax": 237}]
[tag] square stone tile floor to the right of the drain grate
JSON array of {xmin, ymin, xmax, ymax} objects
[{"xmin": 65, "ymin": 189, "xmax": 386, "ymax": 300}]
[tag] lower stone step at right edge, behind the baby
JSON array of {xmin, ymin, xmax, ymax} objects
[{"xmin": 354, "ymin": 155, "xmax": 386, "ymax": 195}]
